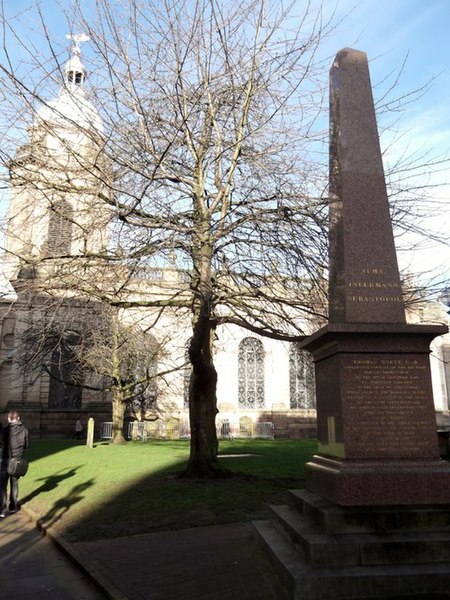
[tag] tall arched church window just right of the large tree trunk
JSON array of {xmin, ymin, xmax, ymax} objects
[{"xmin": 238, "ymin": 338, "xmax": 264, "ymax": 408}]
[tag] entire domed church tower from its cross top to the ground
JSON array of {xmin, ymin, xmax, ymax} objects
[{"xmin": 0, "ymin": 35, "xmax": 112, "ymax": 430}]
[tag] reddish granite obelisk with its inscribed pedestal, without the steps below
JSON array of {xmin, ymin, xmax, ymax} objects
[{"xmin": 304, "ymin": 49, "xmax": 450, "ymax": 506}]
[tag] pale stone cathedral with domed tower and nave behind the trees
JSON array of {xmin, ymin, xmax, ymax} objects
[{"xmin": 0, "ymin": 41, "xmax": 450, "ymax": 437}]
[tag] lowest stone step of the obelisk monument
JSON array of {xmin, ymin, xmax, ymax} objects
[{"xmin": 253, "ymin": 521, "xmax": 450, "ymax": 600}]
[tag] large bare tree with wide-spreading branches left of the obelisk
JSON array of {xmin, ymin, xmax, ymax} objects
[{"xmin": 1, "ymin": 0, "xmax": 446, "ymax": 476}]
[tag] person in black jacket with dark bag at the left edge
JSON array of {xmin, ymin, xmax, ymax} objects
[{"xmin": 0, "ymin": 410, "xmax": 29, "ymax": 519}]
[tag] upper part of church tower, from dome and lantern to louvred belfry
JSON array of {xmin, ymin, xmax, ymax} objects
[{"xmin": 4, "ymin": 35, "xmax": 110, "ymax": 281}]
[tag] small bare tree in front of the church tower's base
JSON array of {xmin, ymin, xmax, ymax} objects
[{"xmin": 16, "ymin": 284, "xmax": 184, "ymax": 444}]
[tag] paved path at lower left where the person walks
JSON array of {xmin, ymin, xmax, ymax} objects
[{"xmin": 0, "ymin": 511, "xmax": 105, "ymax": 600}]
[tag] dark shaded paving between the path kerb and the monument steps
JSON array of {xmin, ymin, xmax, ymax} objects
[{"xmin": 73, "ymin": 523, "xmax": 288, "ymax": 600}]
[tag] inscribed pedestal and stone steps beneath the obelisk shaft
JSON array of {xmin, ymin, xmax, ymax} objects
[{"xmin": 254, "ymin": 323, "xmax": 450, "ymax": 600}]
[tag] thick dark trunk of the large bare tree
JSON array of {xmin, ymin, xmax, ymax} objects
[{"xmin": 183, "ymin": 311, "xmax": 229, "ymax": 478}]
